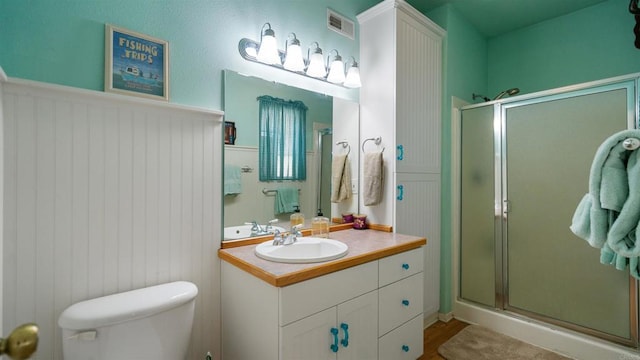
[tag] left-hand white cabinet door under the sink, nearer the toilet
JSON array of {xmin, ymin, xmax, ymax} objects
[{"xmin": 280, "ymin": 307, "xmax": 340, "ymax": 360}]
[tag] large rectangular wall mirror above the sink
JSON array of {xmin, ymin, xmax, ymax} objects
[{"xmin": 223, "ymin": 70, "xmax": 360, "ymax": 240}]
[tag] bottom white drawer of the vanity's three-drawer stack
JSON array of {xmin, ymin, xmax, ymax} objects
[{"xmin": 378, "ymin": 315, "xmax": 424, "ymax": 360}]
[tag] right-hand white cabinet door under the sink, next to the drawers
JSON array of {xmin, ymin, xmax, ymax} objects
[{"xmin": 337, "ymin": 291, "xmax": 378, "ymax": 360}]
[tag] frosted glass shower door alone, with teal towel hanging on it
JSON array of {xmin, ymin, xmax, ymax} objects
[{"xmin": 502, "ymin": 82, "xmax": 637, "ymax": 344}]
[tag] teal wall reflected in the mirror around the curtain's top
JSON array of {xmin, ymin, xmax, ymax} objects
[{"xmin": 224, "ymin": 71, "xmax": 333, "ymax": 151}]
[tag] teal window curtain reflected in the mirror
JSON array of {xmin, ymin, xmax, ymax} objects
[{"xmin": 258, "ymin": 95, "xmax": 307, "ymax": 181}]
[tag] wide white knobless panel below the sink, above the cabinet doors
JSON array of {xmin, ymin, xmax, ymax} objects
[{"xmin": 279, "ymin": 261, "xmax": 378, "ymax": 326}]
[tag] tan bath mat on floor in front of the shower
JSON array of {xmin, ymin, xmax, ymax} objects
[{"xmin": 438, "ymin": 325, "xmax": 570, "ymax": 360}]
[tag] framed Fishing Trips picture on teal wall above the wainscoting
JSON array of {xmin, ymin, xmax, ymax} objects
[{"xmin": 104, "ymin": 24, "xmax": 169, "ymax": 101}]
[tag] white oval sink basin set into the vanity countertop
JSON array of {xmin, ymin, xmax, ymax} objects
[{"xmin": 255, "ymin": 237, "xmax": 349, "ymax": 263}]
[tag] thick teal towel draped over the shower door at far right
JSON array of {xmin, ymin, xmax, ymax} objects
[{"xmin": 570, "ymin": 130, "xmax": 640, "ymax": 278}]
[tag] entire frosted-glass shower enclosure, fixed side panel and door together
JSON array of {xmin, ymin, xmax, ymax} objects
[{"xmin": 458, "ymin": 78, "xmax": 638, "ymax": 347}]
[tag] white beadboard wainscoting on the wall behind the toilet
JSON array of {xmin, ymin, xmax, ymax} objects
[{"xmin": 2, "ymin": 79, "xmax": 222, "ymax": 359}]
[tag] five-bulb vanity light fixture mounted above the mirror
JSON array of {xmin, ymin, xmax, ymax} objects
[{"xmin": 238, "ymin": 23, "xmax": 362, "ymax": 88}]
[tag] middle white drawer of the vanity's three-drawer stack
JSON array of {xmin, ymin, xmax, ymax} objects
[{"xmin": 378, "ymin": 273, "xmax": 424, "ymax": 336}]
